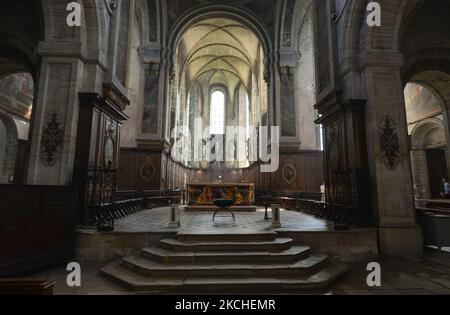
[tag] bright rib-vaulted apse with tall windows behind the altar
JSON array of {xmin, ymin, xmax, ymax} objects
[{"xmin": 172, "ymin": 17, "xmax": 268, "ymax": 169}]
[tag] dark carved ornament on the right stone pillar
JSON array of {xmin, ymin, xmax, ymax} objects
[{"xmin": 380, "ymin": 116, "xmax": 401, "ymax": 171}]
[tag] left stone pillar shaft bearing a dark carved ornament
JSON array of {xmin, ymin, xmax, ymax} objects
[{"xmin": 27, "ymin": 56, "xmax": 84, "ymax": 185}]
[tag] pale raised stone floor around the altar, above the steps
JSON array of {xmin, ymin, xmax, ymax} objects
[{"xmin": 115, "ymin": 208, "xmax": 333, "ymax": 233}]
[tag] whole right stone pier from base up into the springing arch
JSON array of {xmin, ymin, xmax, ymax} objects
[{"xmin": 335, "ymin": 0, "xmax": 436, "ymax": 253}]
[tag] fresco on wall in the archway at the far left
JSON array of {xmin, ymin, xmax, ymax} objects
[{"xmin": 0, "ymin": 73, "xmax": 34, "ymax": 120}]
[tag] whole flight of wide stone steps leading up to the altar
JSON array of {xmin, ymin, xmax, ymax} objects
[{"xmin": 102, "ymin": 232, "xmax": 347, "ymax": 293}]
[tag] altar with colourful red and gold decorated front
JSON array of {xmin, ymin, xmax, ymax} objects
[{"xmin": 185, "ymin": 183, "xmax": 256, "ymax": 212}]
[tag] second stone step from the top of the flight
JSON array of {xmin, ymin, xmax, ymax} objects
[{"xmin": 160, "ymin": 238, "xmax": 293, "ymax": 252}]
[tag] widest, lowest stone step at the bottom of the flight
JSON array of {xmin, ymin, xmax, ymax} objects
[{"xmin": 102, "ymin": 263, "xmax": 347, "ymax": 294}]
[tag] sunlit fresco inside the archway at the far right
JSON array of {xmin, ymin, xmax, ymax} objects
[{"xmin": 405, "ymin": 83, "xmax": 442, "ymax": 125}]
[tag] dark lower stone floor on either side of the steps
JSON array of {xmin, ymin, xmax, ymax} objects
[{"xmin": 33, "ymin": 250, "xmax": 450, "ymax": 295}]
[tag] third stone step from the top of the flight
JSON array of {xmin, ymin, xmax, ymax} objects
[{"xmin": 142, "ymin": 246, "xmax": 311, "ymax": 264}]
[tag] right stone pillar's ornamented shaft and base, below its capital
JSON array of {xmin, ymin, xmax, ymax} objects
[{"xmin": 362, "ymin": 53, "xmax": 423, "ymax": 255}]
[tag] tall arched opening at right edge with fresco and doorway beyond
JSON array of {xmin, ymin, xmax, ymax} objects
[{"xmin": 400, "ymin": 0, "xmax": 450, "ymax": 199}]
